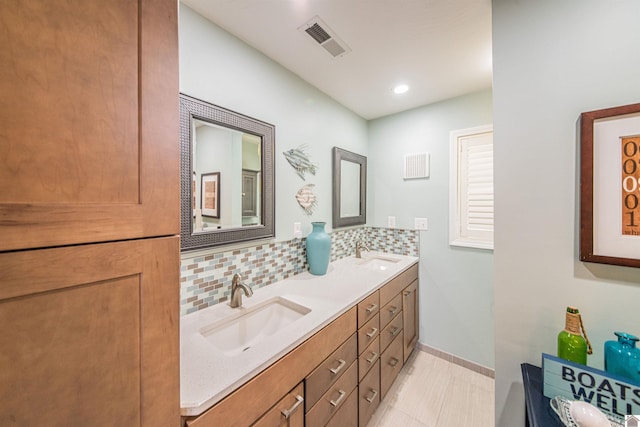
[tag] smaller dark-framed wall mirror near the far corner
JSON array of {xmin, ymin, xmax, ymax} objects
[{"xmin": 333, "ymin": 147, "xmax": 367, "ymax": 228}]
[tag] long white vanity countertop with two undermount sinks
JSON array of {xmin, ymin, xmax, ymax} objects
[{"xmin": 180, "ymin": 252, "xmax": 417, "ymax": 416}]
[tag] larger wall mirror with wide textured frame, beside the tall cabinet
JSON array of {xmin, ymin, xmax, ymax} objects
[{"xmin": 180, "ymin": 94, "xmax": 275, "ymax": 251}]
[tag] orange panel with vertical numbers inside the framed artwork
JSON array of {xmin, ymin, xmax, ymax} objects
[{"xmin": 620, "ymin": 135, "xmax": 640, "ymax": 236}]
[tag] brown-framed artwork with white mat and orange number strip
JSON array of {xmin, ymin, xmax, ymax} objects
[{"xmin": 580, "ymin": 104, "xmax": 640, "ymax": 267}]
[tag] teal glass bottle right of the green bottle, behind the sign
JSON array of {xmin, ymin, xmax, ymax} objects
[{"xmin": 604, "ymin": 332, "xmax": 640, "ymax": 382}]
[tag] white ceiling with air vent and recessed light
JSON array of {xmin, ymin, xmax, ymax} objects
[{"xmin": 181, "ymin": 0, "xmax": 492, "ymax": 119}]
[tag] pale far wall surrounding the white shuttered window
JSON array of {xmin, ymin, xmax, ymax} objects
[{"xmin": 368, "ymin": 89, "xmax": 494, "ymax": 368}]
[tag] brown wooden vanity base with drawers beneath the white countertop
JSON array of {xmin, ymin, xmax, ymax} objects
[{"xmin": 183, "ymin": 266, "xmax": 418, "ymax": 427}]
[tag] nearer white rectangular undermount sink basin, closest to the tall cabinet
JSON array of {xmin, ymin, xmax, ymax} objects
[{"xmin": 200, "ymin": 297, "xmax": 311, "ymax": 356}]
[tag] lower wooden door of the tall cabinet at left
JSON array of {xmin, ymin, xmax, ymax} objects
[{"xmin": 0, "ymin": 237, "xmax": 180, "ymax": 427}]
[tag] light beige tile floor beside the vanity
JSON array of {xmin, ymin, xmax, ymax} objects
[{"xmin": 367, "ymin": 350, "xmax": 495, "ymax": 427}]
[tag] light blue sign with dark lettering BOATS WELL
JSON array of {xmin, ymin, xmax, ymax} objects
[{"xmin": 542, "ymin": 353, "xmax": 640, "ymax": 419}]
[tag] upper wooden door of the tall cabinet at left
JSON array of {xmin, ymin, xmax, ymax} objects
[{"xmin": 0, "ymin": 0, "xmax": 180, "ymax": 251}]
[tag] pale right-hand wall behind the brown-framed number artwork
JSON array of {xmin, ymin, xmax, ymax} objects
[{"xmin": 493, "ymin": 0, "xmax": 640, "ymax": 427}]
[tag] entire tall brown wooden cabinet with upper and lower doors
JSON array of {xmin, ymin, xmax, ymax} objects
[{"xmin": 0, "ymin": 0, "xmax": 180, "ymax": 426}]
